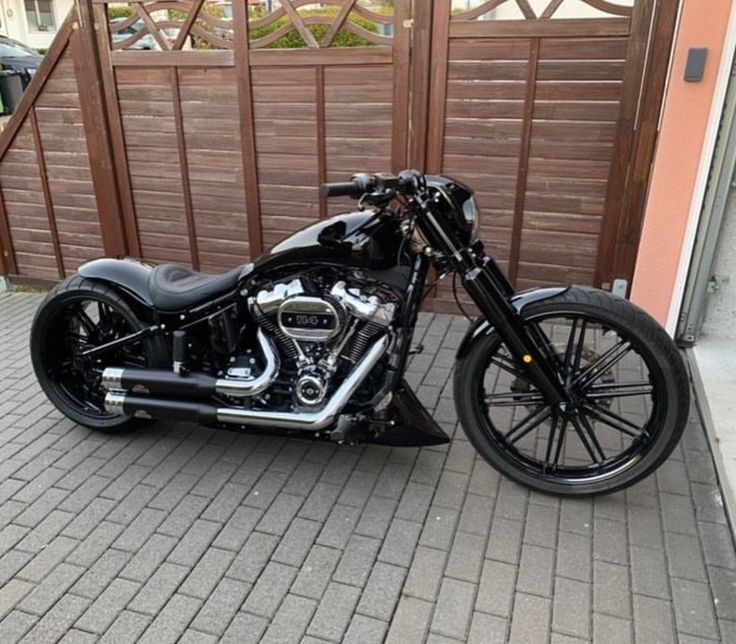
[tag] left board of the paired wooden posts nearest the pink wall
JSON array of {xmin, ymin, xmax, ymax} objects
[{"xmin": 594, "ymin": 0, "xmax": 654, "ymax": 288}]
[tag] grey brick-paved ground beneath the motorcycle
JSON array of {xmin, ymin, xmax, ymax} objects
[{"xmin": 0, "ymin": 294, "xmax": 736, "ymax": 644}]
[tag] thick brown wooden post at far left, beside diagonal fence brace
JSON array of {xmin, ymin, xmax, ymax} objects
[{"xmin": 70, "ymin": 0, "xmax": 127, "ymax": 255}]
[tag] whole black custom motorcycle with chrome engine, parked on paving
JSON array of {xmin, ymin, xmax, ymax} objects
[{"xmin": 31, "ymin": 171, "xmax": 689, "ymax": 495}]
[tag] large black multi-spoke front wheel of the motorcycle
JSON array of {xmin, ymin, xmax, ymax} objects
[{"xmin": 454, "ymin": 287, "xmax": 690, "ymax": 496}]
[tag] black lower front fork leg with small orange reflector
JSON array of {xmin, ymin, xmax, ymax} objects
[{"xmin": 460, "ymin": 258, "xmax": 566, "ymax": 406}]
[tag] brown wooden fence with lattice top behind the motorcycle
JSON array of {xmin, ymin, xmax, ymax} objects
[{"xmin": 0, "ymin": 0, "xmax": 677, "ymax": 310}]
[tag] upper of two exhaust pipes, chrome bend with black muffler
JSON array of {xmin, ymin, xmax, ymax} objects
[{"xmin": 100, "ymin": 329, "xmax": 279, "ymax": 398}]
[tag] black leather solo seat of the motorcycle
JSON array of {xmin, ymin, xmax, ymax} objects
[{"xmin": 148, "ymin": 264, "xmax": 253, "ymax": 311}]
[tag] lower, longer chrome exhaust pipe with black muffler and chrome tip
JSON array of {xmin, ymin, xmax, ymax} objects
[{"xmin": 105, "ymin": 334, "xmax": 390, "ymax": 431}]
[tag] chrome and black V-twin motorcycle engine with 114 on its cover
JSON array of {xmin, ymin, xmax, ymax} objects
[{"xmin": 249, "ymin": 276, "xmax": 400, "ymax": 407}]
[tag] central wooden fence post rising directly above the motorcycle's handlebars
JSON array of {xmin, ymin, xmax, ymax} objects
[{"xmin": 409, "ymin": 2, "xmax": 432, "ymax": 171}]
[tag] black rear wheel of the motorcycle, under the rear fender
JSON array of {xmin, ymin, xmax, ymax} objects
[{"xmin": 31, "ymin": 276, "xmax": 166, "ymax": 431}]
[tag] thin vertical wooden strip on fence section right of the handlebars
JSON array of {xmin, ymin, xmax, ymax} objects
[{"xmin": 508, "ymin": 38, "xmax": 540, "ymax": 284}]
